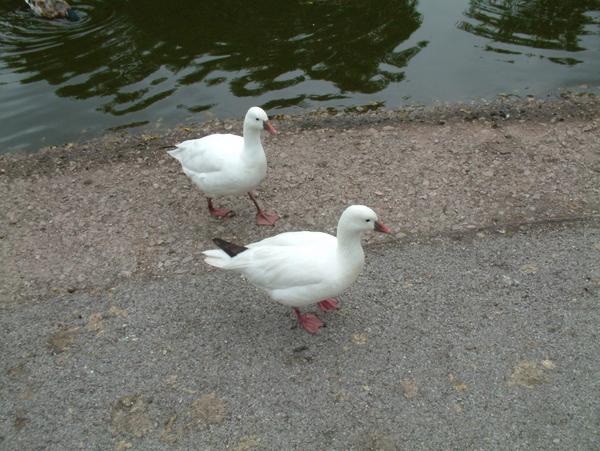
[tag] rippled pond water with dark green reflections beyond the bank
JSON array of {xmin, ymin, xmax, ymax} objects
[{"xmin": 0, "ymin": 0, "xmax": 600, "ymax": 152}]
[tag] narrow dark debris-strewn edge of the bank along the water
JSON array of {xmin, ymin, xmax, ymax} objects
[{"xmin": 0, "ymin": 91, "xmax": 600, "ymax": 173}]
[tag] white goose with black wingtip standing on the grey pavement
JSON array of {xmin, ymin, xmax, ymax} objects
[{"xmin": 203, "ymin": 205, "xmax": 391, "ymax": 333}]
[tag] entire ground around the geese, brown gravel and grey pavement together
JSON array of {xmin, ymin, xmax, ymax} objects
[{"xmin": 0, "ymin": 96, "xmax": 600, "ymax": 449}]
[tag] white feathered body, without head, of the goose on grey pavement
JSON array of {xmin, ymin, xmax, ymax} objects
[{"xmin": 204, "ymin": 232, "xmax": 364, "ymax": 307}]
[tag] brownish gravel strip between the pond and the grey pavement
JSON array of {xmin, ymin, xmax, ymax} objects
[{"xmin": 0, "ymin": 95, "xmax": 600, "ymax": 306}]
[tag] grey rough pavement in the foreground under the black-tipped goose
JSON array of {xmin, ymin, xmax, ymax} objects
[{"xmin": 0, "ymin": 220, "xmax": 600, "ymax": 450}]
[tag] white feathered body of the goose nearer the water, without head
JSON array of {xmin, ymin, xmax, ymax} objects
[{"xmin": 169, "ymin": 134, "xmax": 267, "ymax": 197}]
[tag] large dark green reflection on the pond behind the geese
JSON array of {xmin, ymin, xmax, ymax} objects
[{"xmin": 0, "ymin": 0, "xmax": 425, "ymax": 116}]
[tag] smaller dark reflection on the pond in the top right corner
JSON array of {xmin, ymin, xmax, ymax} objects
[{"xmin": 458, "ymin": 0, "xmax": 600, "ymax": 65}]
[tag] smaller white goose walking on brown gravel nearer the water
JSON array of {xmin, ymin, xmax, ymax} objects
[{"xmin": 168, "ymin": 107, "xmax": 279, "ymax": 225}]
